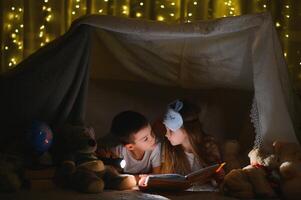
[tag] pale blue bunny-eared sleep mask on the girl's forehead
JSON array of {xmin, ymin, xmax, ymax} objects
[{"xmin": 163, "ymin": 100, "xmax": 183, "ymax": 131}]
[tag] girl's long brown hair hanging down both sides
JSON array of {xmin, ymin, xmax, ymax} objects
[{"xmin": 162, "ymin": 100, "xmax": 218, "ymax": 175}]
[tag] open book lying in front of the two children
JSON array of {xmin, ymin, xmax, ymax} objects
[{"xmin": 139, "ymin": 163, "xmax": 225, "ymax": 190}]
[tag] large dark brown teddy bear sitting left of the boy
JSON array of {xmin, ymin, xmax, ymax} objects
[{"xmin": 53, "ymin": 125, "xmax": 136, "ymax": 193}]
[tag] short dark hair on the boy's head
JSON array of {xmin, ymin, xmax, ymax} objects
[{"xmin": 110, "ymin": 110, "xmax": 149, "ymax": 145}]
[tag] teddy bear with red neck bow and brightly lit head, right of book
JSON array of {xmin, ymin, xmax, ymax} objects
[{"xmin": 221, "ymin": 148, "xmax": 279, "ymax": 198}]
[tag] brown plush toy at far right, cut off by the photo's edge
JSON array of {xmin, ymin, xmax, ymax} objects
[{"xmin": 273, "ymin": 141, "xmax": 301, "ymax": 199}]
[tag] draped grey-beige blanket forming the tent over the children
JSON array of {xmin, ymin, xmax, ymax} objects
[{"xmin": 0, "ymin": 14, "xmax": 298, "ymax": 150}]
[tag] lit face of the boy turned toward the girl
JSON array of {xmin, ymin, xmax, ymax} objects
[{"xmin": 130, "ymin": 125, "xmax": 156, "ymax": 151}]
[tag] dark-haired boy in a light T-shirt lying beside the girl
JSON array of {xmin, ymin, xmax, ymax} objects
[{"xmin": 99, "ymin": 111, "xmax": 161, "ymax": 174}]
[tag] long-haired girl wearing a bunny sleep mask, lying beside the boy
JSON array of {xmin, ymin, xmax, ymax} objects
[{"xmin": 162, "ymin": 100, "xmax": 223, "ymax": 183}]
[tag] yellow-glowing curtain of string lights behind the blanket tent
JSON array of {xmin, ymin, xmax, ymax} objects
[{"xmin": 0, "ymin": 0, "xmax": 301, "ymax": 86}]
